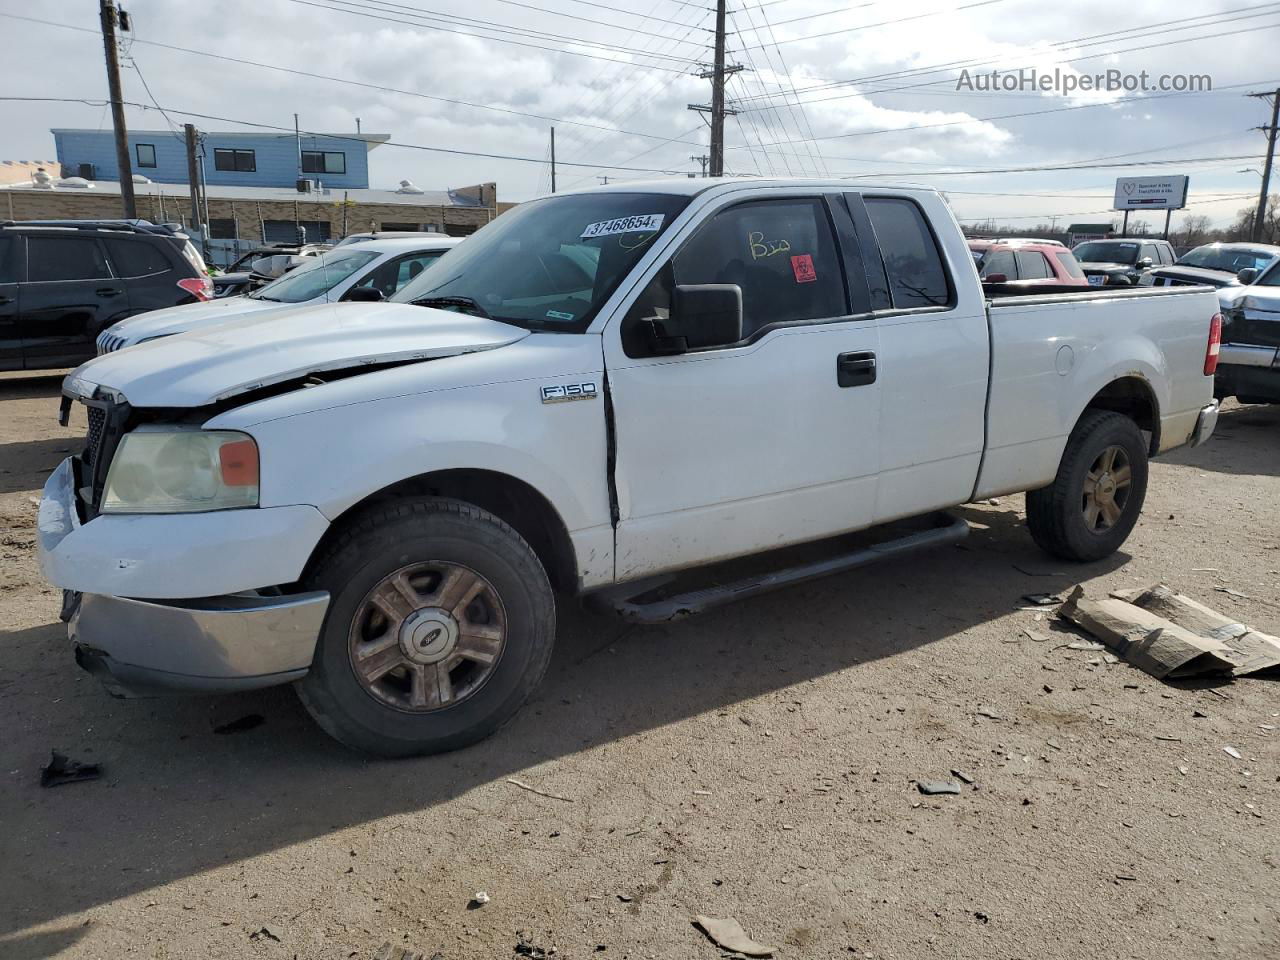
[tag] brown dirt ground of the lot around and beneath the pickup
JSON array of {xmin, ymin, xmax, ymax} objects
[{"xmin": 0, "ymin": 376, "xmax": 1280, "ymax": 960}]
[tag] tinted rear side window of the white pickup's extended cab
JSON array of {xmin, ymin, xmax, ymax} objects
[{"xmin": 867, "ymin": 197, "xmax": 951, "ymax": 310}]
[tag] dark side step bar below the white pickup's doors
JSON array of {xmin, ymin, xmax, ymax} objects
[{"xmin": 593, "ymin": 513, "xmax": 969, "ymax": 623}]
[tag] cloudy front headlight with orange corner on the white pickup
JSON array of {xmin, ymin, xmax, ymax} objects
[{"xmin": 101, "ymin": 428, "xmax": 257, "ymax": 513}]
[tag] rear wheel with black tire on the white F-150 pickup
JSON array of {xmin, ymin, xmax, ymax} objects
[{"xmin": 1027, "ymin": 411, "xmax": 1147, "ymax": 563}]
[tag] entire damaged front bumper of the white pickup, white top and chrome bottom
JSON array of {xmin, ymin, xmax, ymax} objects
[{"xmin": 37, "ymin": 460, "xmax": 329, "ymax": 695}]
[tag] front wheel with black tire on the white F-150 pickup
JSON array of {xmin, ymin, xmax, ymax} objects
[{"xmin": 294, "ymin": 498, "xmax": 556, "ymax": 756}]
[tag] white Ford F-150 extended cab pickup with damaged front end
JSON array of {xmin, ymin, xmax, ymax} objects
[{"xmin": 38, "ymin": 179, "xmax": 1221, "ymax": 755}]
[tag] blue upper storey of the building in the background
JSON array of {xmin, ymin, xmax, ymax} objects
[{"xmin": 51, "ymin": 129, "xmax": 390, "ymax": 189}]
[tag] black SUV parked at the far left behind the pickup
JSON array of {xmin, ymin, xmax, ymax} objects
[{"xmin": 0, "ymin": 220, "xmax": 214, "ymax": 370}]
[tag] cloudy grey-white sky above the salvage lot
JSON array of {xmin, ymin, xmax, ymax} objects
[{"xmin": 0, "ymin": 0, "xmax": 1280, "ymax": 227}]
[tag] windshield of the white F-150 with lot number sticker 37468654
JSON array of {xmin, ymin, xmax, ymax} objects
[{"xmin": 392, "ymin": 192, "xmax": 689, "ymax": 333}]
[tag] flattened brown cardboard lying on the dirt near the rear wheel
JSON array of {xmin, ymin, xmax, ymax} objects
[{"xmin": 1059, "ymin": 585, "xmax": 1280, "ymax": 680}]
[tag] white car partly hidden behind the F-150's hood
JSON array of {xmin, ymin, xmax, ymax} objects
[{"xmin": 97, "ymin": 234, "xmax": 462, "ymax": 355}]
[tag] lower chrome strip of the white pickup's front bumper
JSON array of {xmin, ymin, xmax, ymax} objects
[{"xmin": 68, "ymin": 593, "xmax": 329, "ymax": 696}]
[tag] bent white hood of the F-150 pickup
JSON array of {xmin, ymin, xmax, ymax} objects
[{"xmin": 63, "ymin": 302, "xmax": 529, "ymax": 407}]
